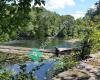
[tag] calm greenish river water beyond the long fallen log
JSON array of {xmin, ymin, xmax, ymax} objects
[{"xmin": 2, "ymin": 39, "xmax": 78, "ymax": 49}]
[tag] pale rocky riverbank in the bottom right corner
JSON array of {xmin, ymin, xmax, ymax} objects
[{"xmin": 53, "ymin": 52, "xmax": 100, "ymax": 80}]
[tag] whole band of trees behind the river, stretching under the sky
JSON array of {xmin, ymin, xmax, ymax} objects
[{"xmin": 0, "ymin": 0, "xmax": 100, "ymax": 41}]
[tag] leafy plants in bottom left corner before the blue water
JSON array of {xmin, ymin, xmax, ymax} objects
[{"xmin": 0, "ymin": 67, "xmax": 36, "ymax": 80}]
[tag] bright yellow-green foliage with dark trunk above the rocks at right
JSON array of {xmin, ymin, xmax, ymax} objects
[{"xmin": 81, "ymin": 18, "xmax": 100, "ymax": 59}]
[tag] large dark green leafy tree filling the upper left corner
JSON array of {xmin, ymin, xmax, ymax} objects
[{"xmin": 0, "ymin": 0, "xmax": 45, "ymax": 40}]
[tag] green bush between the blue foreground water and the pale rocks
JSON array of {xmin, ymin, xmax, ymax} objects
[{"xmin": 47, "ymin": 53, "xmax": 78, "ymax": 79}]
